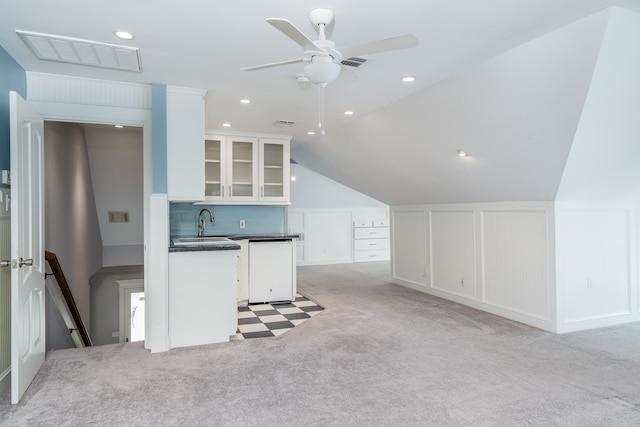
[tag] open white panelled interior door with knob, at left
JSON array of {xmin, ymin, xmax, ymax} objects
[{"xmin": 10, "ymin": 92, "xmax": 45, "ymax": 403}]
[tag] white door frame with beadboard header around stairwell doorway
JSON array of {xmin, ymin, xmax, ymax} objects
[{"xmin": 26, "ymin": 72, "xmax": 169, "ymax": 352}]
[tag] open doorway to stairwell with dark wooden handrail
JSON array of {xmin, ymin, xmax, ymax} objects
[{"xmin": 44, "ymin": 121, "xmax": 145, "ymax": 350}]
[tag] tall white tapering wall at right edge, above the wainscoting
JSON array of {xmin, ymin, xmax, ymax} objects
[{"xmin": 557, "ymin": 9, "xmax": 640, "ymax": 200}]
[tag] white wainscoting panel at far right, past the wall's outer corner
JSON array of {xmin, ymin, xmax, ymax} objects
[{"xmin": 559, "ymin": 206, "xmax": 635, "ymax": 325}]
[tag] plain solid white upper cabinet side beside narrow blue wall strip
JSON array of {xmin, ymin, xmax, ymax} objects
[{"xmin": 167, "ymin": 86, "xmax": 206, "ymax": 201}]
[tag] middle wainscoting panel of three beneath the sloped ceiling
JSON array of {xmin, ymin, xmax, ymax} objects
[{"xmin": 429, "ymin": 210, "xmax": 476, "ymax": 299}]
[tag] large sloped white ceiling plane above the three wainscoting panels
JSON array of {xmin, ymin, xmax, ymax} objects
[{"xmin": 292, "ymin": 10, "xmax": 610, "ymax": 205}]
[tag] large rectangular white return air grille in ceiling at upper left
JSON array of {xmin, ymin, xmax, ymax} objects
[{"xmin": 16, "ymin": 30, "xmax": 142, "ymax": 71}]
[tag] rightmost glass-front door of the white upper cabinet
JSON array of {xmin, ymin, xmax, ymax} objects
[{"xmin": 260, "ymin": 138, "xmax": 289, "ymax": 202}]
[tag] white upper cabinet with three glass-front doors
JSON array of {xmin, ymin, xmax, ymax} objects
[{"xmin": 204, "ymin": 135, "xmax": 290, "ymax": 205}]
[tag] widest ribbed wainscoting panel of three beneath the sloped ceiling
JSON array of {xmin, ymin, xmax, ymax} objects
[{"xmin": 481, "ymin": 210, "xmax": 551, "ymax": 320}]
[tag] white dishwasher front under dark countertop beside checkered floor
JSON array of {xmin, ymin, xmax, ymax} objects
[{"xmin": 249, "ymin": 240, "xmax": 294, "ymax": 303}]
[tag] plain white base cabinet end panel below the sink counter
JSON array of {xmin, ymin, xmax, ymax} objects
[{"xmin": 169, "ymin": 250, "xmax": 238, "ymax": 348}]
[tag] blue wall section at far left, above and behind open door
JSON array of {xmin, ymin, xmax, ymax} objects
[{"xmin": 0, "ymin": 46, "xmax": 27, "ymax": 169}]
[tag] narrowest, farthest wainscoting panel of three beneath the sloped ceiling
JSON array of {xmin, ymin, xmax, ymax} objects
[{"xmin": 391, "ymin": 209, "xmax": 429, "ymax": 288}]
